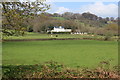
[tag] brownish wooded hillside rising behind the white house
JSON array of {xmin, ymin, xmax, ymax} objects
[{"xmin": 30, "ymin": 12, "xmax": 118, "ymax": 35}]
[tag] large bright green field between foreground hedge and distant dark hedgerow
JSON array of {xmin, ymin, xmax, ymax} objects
[{"xmin": 2, "ymin": 40, "xmax": 118, "ymax": 68}]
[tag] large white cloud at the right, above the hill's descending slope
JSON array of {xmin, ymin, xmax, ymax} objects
[{"xmin": 80, "ymin": 2, "xmax": 118, "ymax": 17}]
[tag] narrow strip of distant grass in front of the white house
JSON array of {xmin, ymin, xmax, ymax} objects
[{"xmin": 3, "ymin": 33, "xmax": 104, "ymax": 39}]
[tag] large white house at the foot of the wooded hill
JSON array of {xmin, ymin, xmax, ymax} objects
[{"xmin": 47, "ymin": 26, "xmax": 72, "ymax": 34}]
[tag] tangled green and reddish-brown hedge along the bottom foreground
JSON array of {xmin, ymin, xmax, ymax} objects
[{"xmin": 3, "ymin": 61, "xmax": 119, "ymax": 79}]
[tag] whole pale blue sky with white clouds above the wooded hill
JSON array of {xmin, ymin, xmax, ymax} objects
[{"xmin": 47, "ymin": 1, "xmax": 118, "ymax": 17}]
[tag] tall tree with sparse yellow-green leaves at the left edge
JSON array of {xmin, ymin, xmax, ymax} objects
[{"xmin": 1, "ymin": 1, "xmax": 50, "ymax": 36}]
